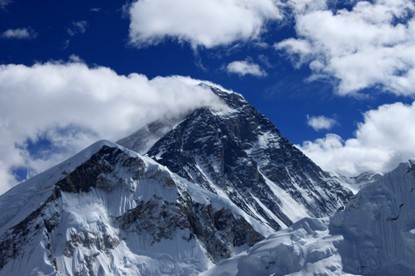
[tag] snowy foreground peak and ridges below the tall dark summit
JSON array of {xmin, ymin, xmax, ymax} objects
[{"xmin": 0, "ymin": 141, "xmax": 415, "ymax": 275}]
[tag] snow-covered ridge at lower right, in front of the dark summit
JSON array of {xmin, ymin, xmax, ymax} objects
[{"xmin": 206, "ymin": 160, "xmax": 415, "ymax": 276}]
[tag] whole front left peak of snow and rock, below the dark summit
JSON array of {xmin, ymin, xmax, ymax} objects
[{"xmin": 0, "ymin": 142, "xmax": 270, "ymax": 275}]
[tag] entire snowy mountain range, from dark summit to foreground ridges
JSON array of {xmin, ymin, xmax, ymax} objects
[{"xmin": 0, "ymin": 84, "xmax": 415, "ymax": 275}]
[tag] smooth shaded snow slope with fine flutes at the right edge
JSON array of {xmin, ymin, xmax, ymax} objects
[{"xmin": 330, "ymin": 160, "xmax": 415, "ymax": 275}]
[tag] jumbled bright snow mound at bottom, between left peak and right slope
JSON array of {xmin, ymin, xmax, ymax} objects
[{"xmin": 201, "ymin": 218, "xmax": 345, "ymax": 276}]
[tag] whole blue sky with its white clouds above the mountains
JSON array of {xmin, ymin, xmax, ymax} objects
[{"xmin": 0, "ymin": 0, "xmax": 415, "ymax": 192}]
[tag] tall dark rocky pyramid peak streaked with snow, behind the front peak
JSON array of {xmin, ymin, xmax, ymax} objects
[{"xmin": 119, "ymin": 87, "xmax": 352, "ymax": 230}]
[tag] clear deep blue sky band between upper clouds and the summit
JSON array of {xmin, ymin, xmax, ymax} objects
[{"xmin": 0, "ymin": 1, "xmax": 404, "ymax": 143}]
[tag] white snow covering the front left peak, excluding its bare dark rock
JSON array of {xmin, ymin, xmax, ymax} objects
[{"xmin": 0, "ymin": 141, "xmax": 272, "ymax": 275}]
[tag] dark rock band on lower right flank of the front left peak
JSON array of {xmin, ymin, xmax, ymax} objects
[{"xmin": 117, "ymin": 195, "xmax": 264, "ymax": 263}]
